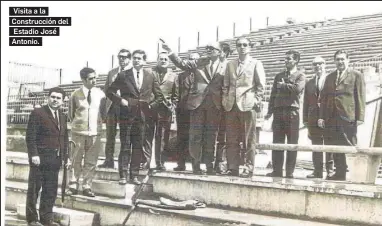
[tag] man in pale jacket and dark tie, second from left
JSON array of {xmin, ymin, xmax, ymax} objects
[{"xmin": 69, "ymin": 68, "xmax": 106, "ymax": 197}]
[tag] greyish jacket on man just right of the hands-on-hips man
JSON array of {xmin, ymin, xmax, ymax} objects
[{"xmin": 151, "ymin": 67, "xmax": 178, "ymax": 114}]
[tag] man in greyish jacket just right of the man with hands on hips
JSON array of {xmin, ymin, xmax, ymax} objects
[{"xmin": 151, "ymin": 53, "xmax": 178, "ymax": 170}]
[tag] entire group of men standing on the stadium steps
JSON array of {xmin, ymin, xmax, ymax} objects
[{"xmin": 26, "ymin": 37, "xmax": 365, "ymax": 226}]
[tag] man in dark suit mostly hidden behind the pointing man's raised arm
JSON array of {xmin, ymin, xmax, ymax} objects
[{"xmin": 174, "ymin": 53, "xmax": 200, "ymax": 171}]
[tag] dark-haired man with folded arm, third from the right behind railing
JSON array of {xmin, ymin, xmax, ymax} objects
[{"xmin": 265, "ymin": 50, "xmax": 305, "ymax": 178}]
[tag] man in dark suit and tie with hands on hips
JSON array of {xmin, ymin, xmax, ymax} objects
[{"xmin": 107, "ymin": 50, "xmax": 164, "ymax": 184}]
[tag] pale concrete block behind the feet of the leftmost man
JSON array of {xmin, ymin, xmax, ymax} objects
[{"xmin": 17, "ymin": 203, "xmax": 100, "ymax": 226}]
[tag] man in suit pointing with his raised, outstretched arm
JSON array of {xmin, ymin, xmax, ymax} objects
[{"xmin": 162, "ymin": 43, "xmax": 226, "ymax": 174}]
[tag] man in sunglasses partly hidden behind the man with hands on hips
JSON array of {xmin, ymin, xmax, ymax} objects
[{"xmin": 98, "ymin": 49, "xmax": 131, "ymax": 168}]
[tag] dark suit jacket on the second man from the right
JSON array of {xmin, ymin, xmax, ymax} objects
[{"xmin": 302, "ymin": 77, "xmax": 323, "ymax": 139}]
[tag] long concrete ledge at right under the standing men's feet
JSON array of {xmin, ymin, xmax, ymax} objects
[{"xmin": 152, "ymin": 172, "xmax": 382, "ymax": 225}]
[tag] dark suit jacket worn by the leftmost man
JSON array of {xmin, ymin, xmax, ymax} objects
[{"xmin": 25, "ymin": 105, "xmax": 69, "ymax": 161}]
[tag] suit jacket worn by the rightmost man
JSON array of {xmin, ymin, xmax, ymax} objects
[{"xmin": 320, "ymin": 68, "xmax": 366, "ymax": 122}]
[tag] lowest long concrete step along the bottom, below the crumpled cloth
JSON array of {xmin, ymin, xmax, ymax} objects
[{"xmin": 6, "ymin": 181, "xmax": 352, "ymax": 226}]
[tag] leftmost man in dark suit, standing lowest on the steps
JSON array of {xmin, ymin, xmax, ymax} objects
[{"xmin": 26, "ymin": 87, "xmax": 69, "ymax": 226}]
